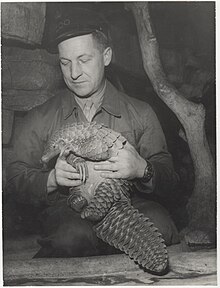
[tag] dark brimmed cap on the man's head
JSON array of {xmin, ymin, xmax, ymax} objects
[{"xmin": 48, "ymin": 7, "xmax": 109, "ymax": 52}]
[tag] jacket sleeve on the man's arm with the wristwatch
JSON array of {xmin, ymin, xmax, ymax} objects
[{"xmin": 136, "ymin": 106, "xmax": 179, "ymax": 196}]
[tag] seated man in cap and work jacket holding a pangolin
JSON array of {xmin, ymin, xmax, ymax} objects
[{"xmin": 7, "ymin": 9, "xmax": 178, "ymax": 257}]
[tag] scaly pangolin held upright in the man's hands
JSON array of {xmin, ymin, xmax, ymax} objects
[{"xmin": 41, "ymin": 122, "xmax": 168, "ymax": 274}]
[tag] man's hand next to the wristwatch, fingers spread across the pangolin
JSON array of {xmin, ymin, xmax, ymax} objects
[{"xmin": 94, "ymin": 142, "xmax": 147, "ymax": 180}]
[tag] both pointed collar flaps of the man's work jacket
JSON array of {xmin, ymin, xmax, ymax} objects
[{"xmin": 62, "ymin": 80, "xmax": 121, "ymax": 119}]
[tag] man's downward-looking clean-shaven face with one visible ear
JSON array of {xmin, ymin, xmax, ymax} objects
[{"xmin": 58, "ymin": 34, "xmax": 112, "ymax": 97}]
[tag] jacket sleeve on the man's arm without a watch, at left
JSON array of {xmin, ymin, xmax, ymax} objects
[{"xmin": 6, "ymin": 109, "xmax": 58, "ymax": 206}]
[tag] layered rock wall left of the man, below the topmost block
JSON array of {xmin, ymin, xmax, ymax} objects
[{"xmin": 2, "ymin": 47, "xmax": 63, "ymax": 187}]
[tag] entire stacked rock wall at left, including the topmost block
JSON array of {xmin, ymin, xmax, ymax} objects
[{"xmin": 1, "ymin": 2, "xmax": 62, "ymax": 187}]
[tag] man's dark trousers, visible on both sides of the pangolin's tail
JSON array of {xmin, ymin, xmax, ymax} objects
[{"xmin": 34, "ymin": 197, "xmax": 179, "ymax": 258}]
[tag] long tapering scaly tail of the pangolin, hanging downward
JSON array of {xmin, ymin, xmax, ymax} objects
[{"xmin": 94, "ymin": 201, "xmax": 168, "ymax": 275}]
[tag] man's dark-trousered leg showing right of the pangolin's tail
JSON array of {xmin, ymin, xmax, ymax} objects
[{"xmin": 133, "ymin": 199, "xmax": 179, "ymax": 245}]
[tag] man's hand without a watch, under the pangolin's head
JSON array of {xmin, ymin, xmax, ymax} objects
[{"xmin": 47, "ymin": 157, "xmax": 82, "ymax": 193}]
